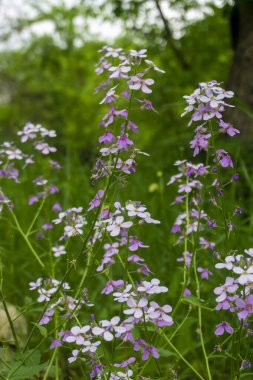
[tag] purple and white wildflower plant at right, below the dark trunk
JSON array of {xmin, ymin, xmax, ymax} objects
[{"xmin": 168, "ymin": 81, "xmax": 253, "ymax": 379}]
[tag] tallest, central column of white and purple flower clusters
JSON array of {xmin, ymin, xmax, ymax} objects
[{"xmin": 24, "ymin": 46, "xmax": 174, "ymax": 380}]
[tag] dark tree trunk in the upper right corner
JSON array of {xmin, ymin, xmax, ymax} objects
[{"xmin": 228, "ymin": 0, "xmax": 253, "ymax": 137}]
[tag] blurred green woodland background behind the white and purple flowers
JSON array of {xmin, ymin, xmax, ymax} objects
[{"xmin": 0, "ymin": 0, "xmax": 253, "ymax": 379}]
